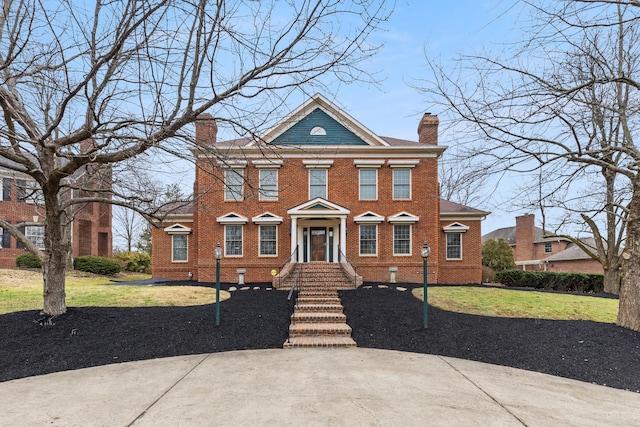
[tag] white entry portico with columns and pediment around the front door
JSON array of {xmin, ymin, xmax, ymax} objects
[{"xmin": 287, "ymin": 198, "xmax": 350, "ymax": 262}]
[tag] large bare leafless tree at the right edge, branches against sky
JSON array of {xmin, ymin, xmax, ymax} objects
[{"xmin": 420, "ymin": 1, "xmax": 640, "ymax": 330}]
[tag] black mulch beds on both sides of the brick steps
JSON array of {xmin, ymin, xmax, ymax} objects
[{"xmin": 0, "ymin": 283, "xmax": 640, "ymax": 392}]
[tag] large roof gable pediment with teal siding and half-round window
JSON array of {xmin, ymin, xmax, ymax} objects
[{"xmin": 260, "ymin": 94, "xmax": 389, "ymax": 146}]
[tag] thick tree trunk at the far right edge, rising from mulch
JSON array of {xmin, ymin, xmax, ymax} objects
[{"xmin": 616, "ymin": 191, "xmax": 640, "ymax": 331}]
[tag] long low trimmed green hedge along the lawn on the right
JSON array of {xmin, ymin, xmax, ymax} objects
[{"xmin": 496, "ymin": 270, "xmax": 604, "ymax": 292}]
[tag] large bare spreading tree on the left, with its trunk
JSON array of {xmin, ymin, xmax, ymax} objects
[{"xmin": 0, "ymin": 0, "xmax": 388, "ymax": 315}]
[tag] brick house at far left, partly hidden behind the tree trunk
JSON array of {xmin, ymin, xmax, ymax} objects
[{"xmin": 0, "ymin": 168, "xmax": 112, "ymax": 268}]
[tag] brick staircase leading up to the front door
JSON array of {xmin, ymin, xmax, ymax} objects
[{"xmin": 283, "ymin": 263, "xmax": 356, "ymax": 348}]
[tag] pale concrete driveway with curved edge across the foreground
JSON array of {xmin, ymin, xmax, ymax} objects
[{"xmin": 0, "ymin": 348, "xmax": 640, "ymax": 427}]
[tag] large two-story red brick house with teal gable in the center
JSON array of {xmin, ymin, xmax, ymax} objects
[{"xmin": 152, "ymin": 95, "xmax": 488, "ymax": 283}]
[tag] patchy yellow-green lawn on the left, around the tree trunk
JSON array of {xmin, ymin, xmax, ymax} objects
[{"xmin": 0, "ymin": 269, "xmax": 230, "ymax": 314}]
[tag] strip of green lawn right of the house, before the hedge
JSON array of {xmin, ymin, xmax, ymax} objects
[{"xmin": 413, "ymin": 286, "xmax": 618, "ymax": 323}]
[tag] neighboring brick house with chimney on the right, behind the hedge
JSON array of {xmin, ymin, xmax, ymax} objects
[{"xmin": 482, "ymin": 214, "xmax": 603, "ymax": 274}]
